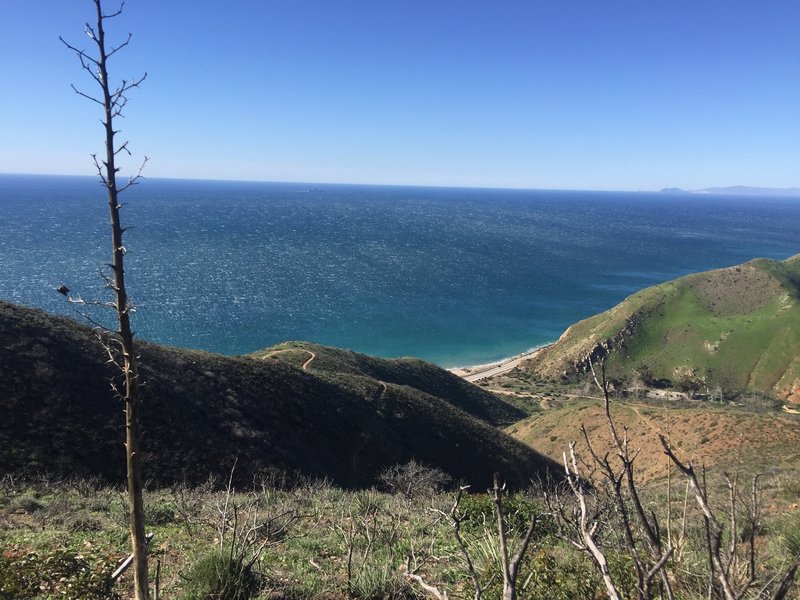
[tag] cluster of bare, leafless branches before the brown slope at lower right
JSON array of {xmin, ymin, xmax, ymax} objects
[{"xmin": 545, "ymin": 356, "xmax": 800, "ymax": 600}]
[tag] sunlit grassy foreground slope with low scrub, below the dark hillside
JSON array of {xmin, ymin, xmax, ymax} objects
[{"xmin": 0, "ymin": 476, "xmax": 800, "ymax": 600}]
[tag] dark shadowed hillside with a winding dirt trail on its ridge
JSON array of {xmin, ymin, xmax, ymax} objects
[{"xmin": 0, "ymin": 302, "xmax": 558, "ymax": 487}]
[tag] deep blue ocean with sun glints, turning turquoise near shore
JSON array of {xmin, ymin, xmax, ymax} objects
[{"xmin": 0, "ymin": 175, "xmax": 800, "ymax": 367}]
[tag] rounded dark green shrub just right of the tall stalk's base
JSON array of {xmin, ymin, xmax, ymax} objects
[{"xmin": 181, "ymin": 549, "xmax": 261, "ymax": 600}]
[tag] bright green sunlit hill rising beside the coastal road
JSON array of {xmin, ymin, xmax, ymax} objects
[{"xmin": 521, "ymin": 255, "xmax": 800, "ymax": 403}]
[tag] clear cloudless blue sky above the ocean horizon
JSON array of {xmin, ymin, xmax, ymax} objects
[{"xmin": 0, "ymin": 0, "xmax": 800, "ymax": 190}]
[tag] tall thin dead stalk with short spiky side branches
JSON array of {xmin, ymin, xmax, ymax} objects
[{"xmin": 59, "ymin": 0, "xmax": 149, "ymax": 600}]
